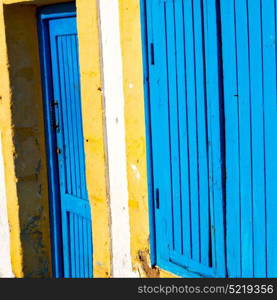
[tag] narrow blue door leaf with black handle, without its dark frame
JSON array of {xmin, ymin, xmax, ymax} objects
[{"xmin": 49, "ymin": 17, "xmax": 92, "ymax": 277}]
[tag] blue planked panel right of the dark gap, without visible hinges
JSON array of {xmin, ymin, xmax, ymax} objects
[{"xmin": 220, "ymin": 0, "xmax": 277, "ymax": 277}]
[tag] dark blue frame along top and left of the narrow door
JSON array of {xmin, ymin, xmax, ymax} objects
[{"xmin": 37, "ymin": 2, "xmax": 76, "ymax": 278}]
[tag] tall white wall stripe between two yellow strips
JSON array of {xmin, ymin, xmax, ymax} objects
[{"xmin": 99, "ymin": 0, "xmax": 136, "ymax": 277}]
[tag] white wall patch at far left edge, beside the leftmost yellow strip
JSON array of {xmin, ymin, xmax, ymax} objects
[{"xmin": 0, "ymin": 132, "xmax": 14, "ymax": 278}]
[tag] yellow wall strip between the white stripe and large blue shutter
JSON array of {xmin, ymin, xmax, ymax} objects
[{"xmin": 118, "ymin": 0, "xmax": 175, "ymax": 277}]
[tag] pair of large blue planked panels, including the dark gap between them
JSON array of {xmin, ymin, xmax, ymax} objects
[{"xmin": 146, "ymin": 0, "xmax": 277, "ymax": 277}]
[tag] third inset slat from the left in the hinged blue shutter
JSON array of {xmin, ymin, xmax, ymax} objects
[{"xmin": 184, "ymin": 0, "xmax": 200, "ymax": 261}]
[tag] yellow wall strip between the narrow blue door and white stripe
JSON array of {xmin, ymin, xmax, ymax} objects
[{"xmin": 77, "ymin": 0, "xmax": 112, "ymax": 277}]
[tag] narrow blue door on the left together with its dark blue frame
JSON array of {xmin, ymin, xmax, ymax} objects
[{"xmin": 37, "ymin": 5, "xmax": 92, "ymax": 278}]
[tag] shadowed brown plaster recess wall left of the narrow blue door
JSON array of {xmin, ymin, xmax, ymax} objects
[{"xmin": 4, "ymin": 5, "xmax": 51, "ymax": 277}]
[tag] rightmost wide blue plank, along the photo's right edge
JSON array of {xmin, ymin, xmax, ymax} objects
[{"xmin": 261, "ymin": 0, "xmax": 277, "ymax": 278}]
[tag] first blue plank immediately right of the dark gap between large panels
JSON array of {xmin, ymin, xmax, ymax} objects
[{"xmin": 220, "ymin": 0, "xmax": 241, "ymax": 277}]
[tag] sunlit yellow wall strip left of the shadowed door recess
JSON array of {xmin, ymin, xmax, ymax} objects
[{"xmin": 0, "ymin": 4, "xmax": 23, "ymax": 276}]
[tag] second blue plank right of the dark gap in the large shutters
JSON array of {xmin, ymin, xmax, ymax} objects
[{"xmin": 233, "ymin": 0, "xmax": 253, "ymax": 277}]
